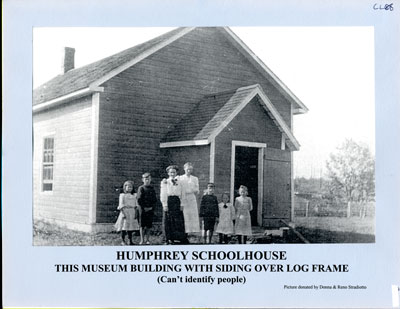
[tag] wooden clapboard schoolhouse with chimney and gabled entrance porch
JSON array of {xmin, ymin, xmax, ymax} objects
[{"xmin": 33, "ymin": 27, "xmax": 307, "ymax": 231}]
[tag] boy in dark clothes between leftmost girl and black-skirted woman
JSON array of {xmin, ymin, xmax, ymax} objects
[{"xmin": 137, "ymin": 173, "xmax": 157, "ymax": 245}]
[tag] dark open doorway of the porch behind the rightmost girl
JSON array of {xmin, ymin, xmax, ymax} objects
[{"xmin": 234, "ymin": 146, "xmax": 258, "ymax": 225}]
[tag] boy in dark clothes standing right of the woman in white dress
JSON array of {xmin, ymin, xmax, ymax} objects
[{"xmin": 200, "ymin": 183, "xmax": 219, "ymax": 244}]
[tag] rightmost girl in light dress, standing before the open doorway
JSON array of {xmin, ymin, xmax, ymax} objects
[{"xmin": 235, "ymin": 186, "xmax": 253, "ymax": 244}]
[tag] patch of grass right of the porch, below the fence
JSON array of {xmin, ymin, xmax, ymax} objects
[{"xmin": 293, "ymin": 217, "xmax": 375, "ymax": 243}]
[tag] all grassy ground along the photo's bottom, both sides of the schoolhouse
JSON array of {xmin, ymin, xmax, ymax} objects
[{"xmin": 33, "ymin": 217, "xmax": 375, "ymax": 246}]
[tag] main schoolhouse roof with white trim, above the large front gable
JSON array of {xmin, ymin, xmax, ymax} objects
[{"xmin": 33, "ymin": 27, "xmax": 308, "ymax": 114}]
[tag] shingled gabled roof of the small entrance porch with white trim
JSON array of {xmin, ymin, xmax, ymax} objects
[{"xmin": 160, "ymin": 84, "xmax": 300, "ymax": 150}]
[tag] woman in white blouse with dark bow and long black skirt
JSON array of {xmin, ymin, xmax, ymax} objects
[{"xmin": 160, "ymin": 165, "xmax": 188, "ymax": 244}]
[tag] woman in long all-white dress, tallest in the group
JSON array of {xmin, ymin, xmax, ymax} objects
[{"xmin": 179, "ymin": 162, "xmax": 200, "ymax": 233}]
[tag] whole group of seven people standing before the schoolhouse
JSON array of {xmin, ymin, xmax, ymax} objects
[{"xmin": 115, "ymin": 162, "xmax": 253, "ymax": 245}]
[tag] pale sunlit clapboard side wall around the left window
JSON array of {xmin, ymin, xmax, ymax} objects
[{"xmin": 33, "ymin": 97, "xmax": 92, "ymax": 223}]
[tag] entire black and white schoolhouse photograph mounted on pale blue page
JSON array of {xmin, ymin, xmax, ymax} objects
[{"xmin": 32, "ymin": 27, "xmax": 375, "ymax": 248}]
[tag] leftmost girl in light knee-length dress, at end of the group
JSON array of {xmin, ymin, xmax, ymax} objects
[{"xmin": 115, "ymin": 180, "xmax": 139, "ymax": 245}]
